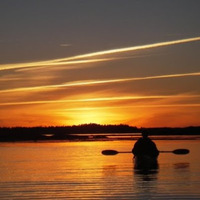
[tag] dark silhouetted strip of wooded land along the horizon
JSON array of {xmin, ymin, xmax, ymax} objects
[{"xmin": 0, "ymin": 124, "xmax": 200, "ymax": 142}]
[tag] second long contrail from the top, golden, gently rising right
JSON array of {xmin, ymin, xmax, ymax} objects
[{"xmin": 0, "ymin": 72, "xmax": 200, "ymax": 93}]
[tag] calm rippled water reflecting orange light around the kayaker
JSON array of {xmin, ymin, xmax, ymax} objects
[{"xmin": 0, "ymin": 140, "xmax": 200, "ymax": 200}]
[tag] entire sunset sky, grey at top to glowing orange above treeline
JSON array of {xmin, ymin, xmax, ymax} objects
[{"xmin": 0, "ymin": 0, "xmax": 200, "ymax": 127}]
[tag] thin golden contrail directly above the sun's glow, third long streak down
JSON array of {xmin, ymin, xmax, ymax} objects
[{"xmin": 0, "ymin": 95, "xmax": 200, "ymax": 106}]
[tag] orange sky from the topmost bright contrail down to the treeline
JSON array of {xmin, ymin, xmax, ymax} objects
[{"xmin": 0, "ymin": 37, "xmax": 200, "ymax": 127}]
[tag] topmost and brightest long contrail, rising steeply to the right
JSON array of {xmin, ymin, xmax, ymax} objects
[{"xmin": 0, "ymin": 37, "xmax": 200, "ymax": 70}]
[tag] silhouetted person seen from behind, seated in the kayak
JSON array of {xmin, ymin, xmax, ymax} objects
[{"xmin": 132, "ymin": 132, "xmax": 159, "ymax": 158}]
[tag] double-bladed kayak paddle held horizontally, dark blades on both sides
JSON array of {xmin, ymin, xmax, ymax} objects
[{"xmin": 101, "ymin": 149, "xmax": 190, "ymax": 156}]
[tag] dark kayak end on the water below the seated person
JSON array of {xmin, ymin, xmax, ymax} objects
[{"xmin": 134, "ymin": 155, "xmax": 158, "ymax": 170}]
